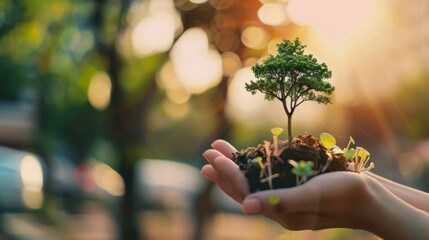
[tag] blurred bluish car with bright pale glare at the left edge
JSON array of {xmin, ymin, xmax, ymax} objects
[{"xmin": 0, "ymin": 146, "xmax": 45, "ymax": 212}]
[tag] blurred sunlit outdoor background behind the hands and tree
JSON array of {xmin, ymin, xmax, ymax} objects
[{"xmin": 0, "ymin": 0, "xmax": 429, "ymax": 240}]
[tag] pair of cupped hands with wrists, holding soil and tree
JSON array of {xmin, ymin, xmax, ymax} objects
[{"xmin": 201, "ymin": 140, "xmax": 429, "ymax": 239}]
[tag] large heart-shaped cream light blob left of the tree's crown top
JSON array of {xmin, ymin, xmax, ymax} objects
[{"xmin": 170, "ymin": 28, "xmax": 222, "ymax": 94}]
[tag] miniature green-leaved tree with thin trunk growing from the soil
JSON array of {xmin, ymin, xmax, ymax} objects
[{"xmin": 246, "ymin": 38, "xmax": 335, "ymax": 142}]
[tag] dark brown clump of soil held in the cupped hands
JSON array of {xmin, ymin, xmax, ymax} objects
[{"xmin": 233, "ymin": 134, "xmax": 348, "ymax": 192}]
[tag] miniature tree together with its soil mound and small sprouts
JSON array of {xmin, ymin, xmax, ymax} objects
[{"xmin": 233, "ymin": 38, "xmax": 374, "ymax": 193}]
